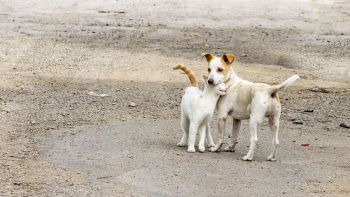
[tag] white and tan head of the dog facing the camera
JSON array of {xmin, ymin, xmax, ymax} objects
[{"xmin": 202, "ymin": 53, "xmax": 235, "ymax": 85}]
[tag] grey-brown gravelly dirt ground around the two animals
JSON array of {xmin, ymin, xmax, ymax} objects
[{"xmin": 0, "ymin": 0, "xmax": 350, "ymax": 197}]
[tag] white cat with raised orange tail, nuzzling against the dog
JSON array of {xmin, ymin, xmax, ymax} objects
[{"xmin": 173, "ymin": 64, "xmax": 227, "ymax": 153}]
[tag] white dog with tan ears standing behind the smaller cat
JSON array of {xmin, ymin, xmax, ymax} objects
[{"xmin": 202, "ymin": 53, "xmax": 299, "ymax": 161}]
